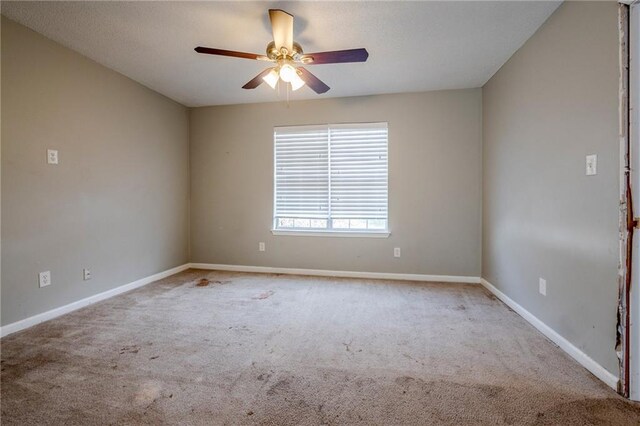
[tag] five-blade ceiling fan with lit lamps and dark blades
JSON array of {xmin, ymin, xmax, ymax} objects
[{"xmin": 195, "ymin": 9, "xmax": 369, "ymax": 94}]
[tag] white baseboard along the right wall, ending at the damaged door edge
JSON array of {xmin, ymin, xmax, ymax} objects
[{"xmin": 480, "ymin": 278, "xmax": 618, "ymax": 390}]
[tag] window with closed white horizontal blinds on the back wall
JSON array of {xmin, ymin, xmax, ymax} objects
[{"xmin": 273, "ymin": 123, "xmax": 388, "ymax": 236}]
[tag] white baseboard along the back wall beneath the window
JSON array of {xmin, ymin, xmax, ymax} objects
[{"xmin": 189, "ymin": 263, "xmax": 480, "ymax": 284}]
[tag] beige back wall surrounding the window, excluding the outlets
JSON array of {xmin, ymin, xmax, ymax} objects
[{"xmin": 190, "ymin": 89, "xmax": 482, "ymax": 276}]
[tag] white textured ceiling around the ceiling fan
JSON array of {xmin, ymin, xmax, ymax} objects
[{"xmin": 2, "ymin": 1, "xmax": 560, "ymax": 106}]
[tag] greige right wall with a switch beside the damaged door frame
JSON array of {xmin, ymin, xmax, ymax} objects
[{"xmin": 482, "ymin": 2, "xmax": 619, "ymax": 375}]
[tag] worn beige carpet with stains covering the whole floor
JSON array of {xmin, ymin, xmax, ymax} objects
[{"xmin": 0, "ymin": 270, "xmax": 640, "ymax": 425}]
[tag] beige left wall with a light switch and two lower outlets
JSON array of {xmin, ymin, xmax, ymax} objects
[{"xmin": 1, "ymin": 17, "xmax": 189, "ymax": 325}]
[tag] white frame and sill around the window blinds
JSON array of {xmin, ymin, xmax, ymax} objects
[{"xmin": 271, "ymin": 121, "xmax": 391, "ymax": 238}]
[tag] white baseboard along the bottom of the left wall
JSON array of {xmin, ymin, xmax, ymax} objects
[{"xmin": 0, "ymin": 263, "xmax": 189, "ymax": 337}]
